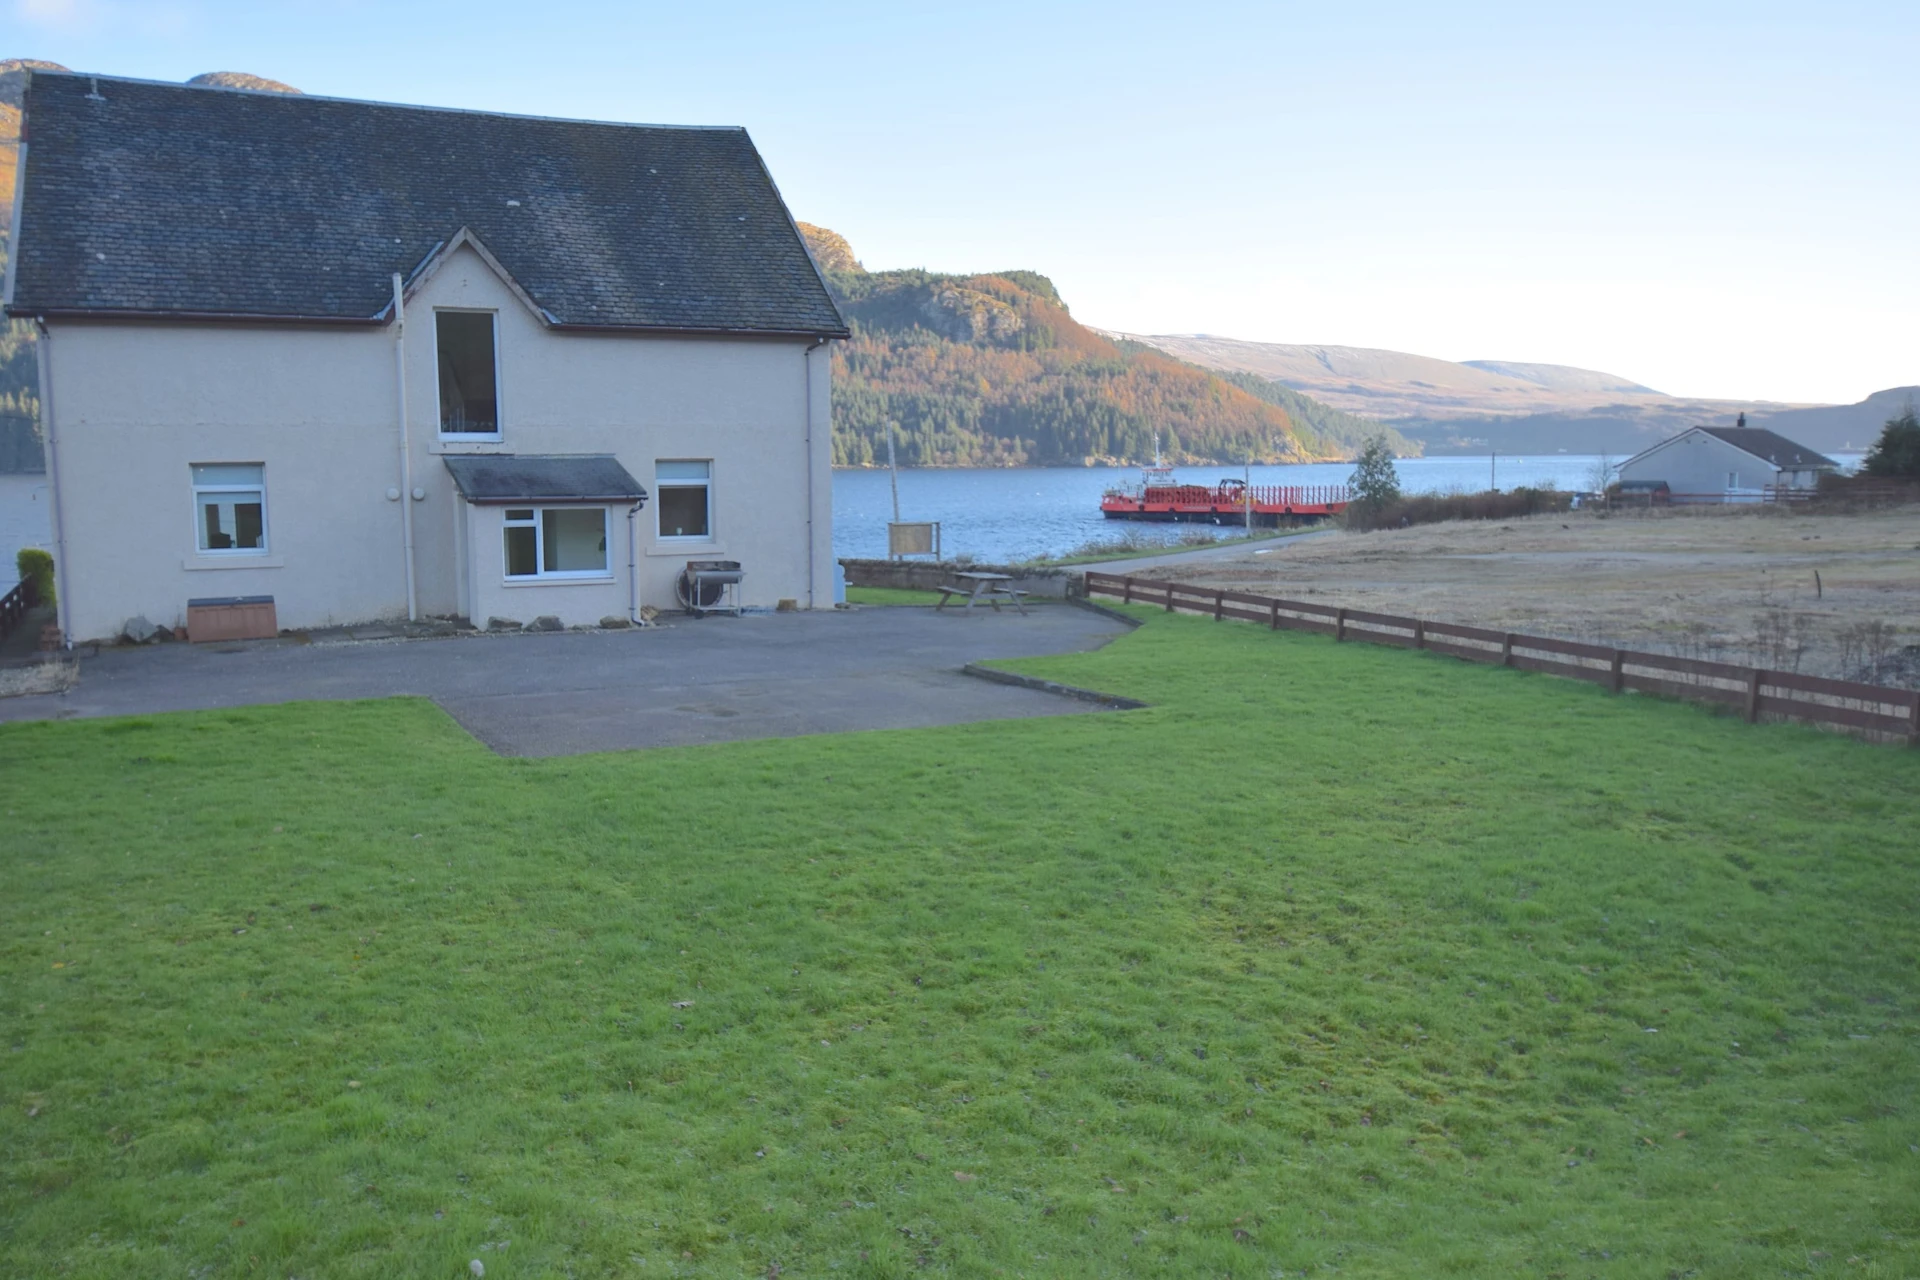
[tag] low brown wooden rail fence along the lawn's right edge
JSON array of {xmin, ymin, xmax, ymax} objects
[{"xmin": 1087, "ymin": 572, "xmax": 1920, "ymax": 747}]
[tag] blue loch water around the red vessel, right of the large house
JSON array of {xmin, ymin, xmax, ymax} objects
[{"xmin": 833, "ymin": 453, "xmax": 1599, "ymax": 564}]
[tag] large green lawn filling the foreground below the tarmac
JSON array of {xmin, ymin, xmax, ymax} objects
[{"xmin": 0, "ymin": 616, "xmax": 1920, "ymax": 1280}]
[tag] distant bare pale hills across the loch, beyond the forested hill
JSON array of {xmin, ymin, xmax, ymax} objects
[{"xmin": 1116, "ymin": 334, "xmax": 1820, "ymax": 455}]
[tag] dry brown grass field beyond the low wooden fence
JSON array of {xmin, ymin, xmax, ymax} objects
[{"xmin": 1137, "ymin": 507, "xmax": 1920, "ymax": 685}]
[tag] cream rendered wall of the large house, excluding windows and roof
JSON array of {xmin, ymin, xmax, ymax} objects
[{"xmin": 39, "ymin": 241, "xmax": 833, "ymax": 639}]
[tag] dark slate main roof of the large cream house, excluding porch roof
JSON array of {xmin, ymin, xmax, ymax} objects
[{"xmin": 10, "ymin": 71, "xmax": 847, "ymax": 336}]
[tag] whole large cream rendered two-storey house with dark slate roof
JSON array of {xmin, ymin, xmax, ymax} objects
[{"xmin": 6, "ymin": 73, "xmax": 847, "ymax": 639}]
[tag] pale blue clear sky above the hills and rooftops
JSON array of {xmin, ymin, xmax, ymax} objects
[{"xmin": 0, "ymin": 0, "xmax": 1920, "ymax": 401}]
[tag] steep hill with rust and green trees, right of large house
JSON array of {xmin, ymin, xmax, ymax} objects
[{"xmin": 801, "ymin": 223, "xmax": 1382, "ymax": 466}]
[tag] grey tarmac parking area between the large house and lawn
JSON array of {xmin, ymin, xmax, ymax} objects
[{"xmin": 0, "ymin": 604, "xmax": 1125, "ymax": 756}]
